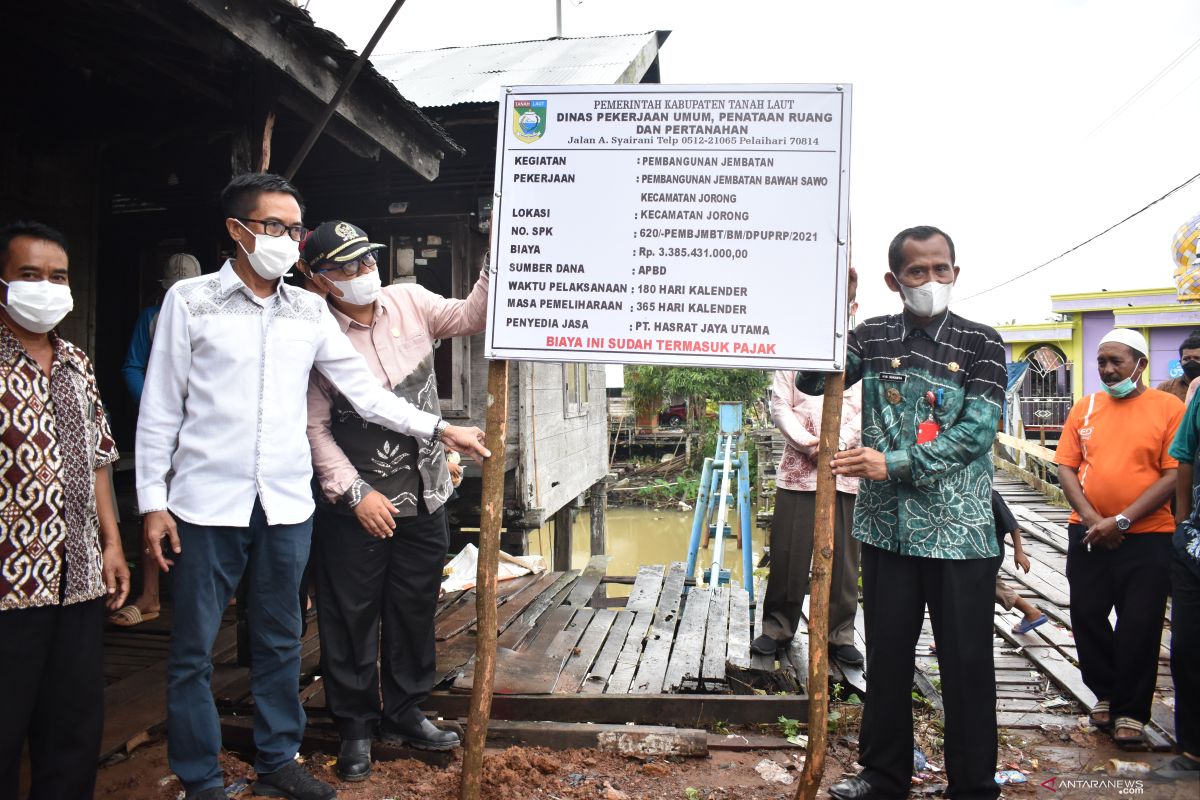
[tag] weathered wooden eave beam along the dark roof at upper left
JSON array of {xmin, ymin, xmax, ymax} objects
[{"xmin": 185, "ymin": 0, "xmax": 444, "ymax": 181}]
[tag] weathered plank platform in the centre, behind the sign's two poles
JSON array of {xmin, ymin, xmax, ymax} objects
[{"xmin": 285, "ymin": 557, "xmax": 806, "ymax": 724}]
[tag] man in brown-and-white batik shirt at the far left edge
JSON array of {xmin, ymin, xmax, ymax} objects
[{"xmin": 0, "ymin": 222, "xmax": 130, "ymax": 798}]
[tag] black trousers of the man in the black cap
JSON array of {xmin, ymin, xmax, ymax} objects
[{"xmin": 313, "ymin": 507, "xmax": 450, "ymax": 739}]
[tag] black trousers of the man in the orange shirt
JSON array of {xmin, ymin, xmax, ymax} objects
[{"xmin": 1067, "ymin": 525, "xmax": 1171, "ymax": 722}]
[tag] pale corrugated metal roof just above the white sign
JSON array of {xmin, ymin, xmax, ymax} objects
[{"xmin": 371, "ymin": 31, "xmax": 670, "ymax": 108}]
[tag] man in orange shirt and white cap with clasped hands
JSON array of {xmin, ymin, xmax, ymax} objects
[{"xmin": 1055, "ymin": 327, "xmax": 1183, "ymax": 744}]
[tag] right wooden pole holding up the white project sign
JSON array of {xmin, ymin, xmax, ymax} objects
[{"xmin": 796, "ymin": 372, "xmax": 846, "ymax": 800}]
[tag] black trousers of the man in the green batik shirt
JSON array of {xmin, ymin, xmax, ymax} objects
[{"xmin": 858, "ymin": 545, "xmax": 1000, "ymax": 800}]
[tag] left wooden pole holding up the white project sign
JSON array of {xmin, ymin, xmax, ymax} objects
[{"xmin": 458, "ymin": 360, "xmax": 509, "ymax": 800}]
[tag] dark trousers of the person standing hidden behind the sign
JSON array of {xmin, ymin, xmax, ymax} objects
[{"xmin": 762, "ymin": 489, "xmax": 859, "ymax": 645}]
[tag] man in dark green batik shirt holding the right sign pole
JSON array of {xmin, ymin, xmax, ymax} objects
[{"xmin": 796, "ymin": 225, "xmax": 1006, "ymax": 800}]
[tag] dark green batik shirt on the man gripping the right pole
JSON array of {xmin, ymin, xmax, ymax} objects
[{"xmin": 796, "ymin": 311, "xmax": 1007, "ymax": 559}]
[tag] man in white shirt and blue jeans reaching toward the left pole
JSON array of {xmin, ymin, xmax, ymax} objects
[{"xmin": 137, "ymin": 174, "xmax": 491, "ymax": 800}]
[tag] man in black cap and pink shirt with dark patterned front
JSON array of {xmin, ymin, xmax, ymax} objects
[{"xmin": 301, "ymin": 221, "xmax": 488, "ymax": 781}]
